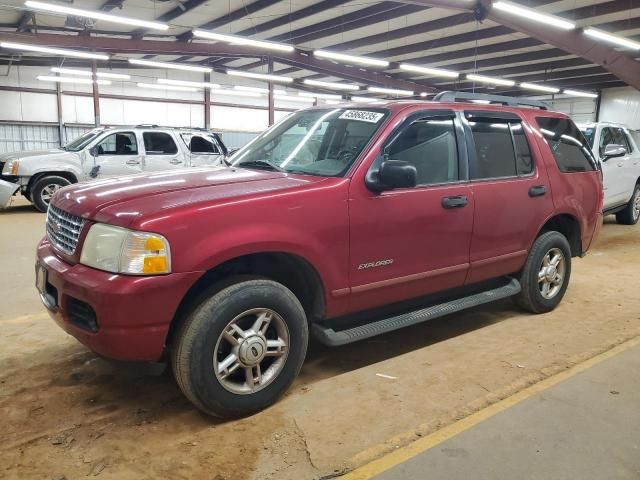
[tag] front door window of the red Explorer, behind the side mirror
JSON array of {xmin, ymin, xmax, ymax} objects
[{"xmin": 387, "ymin": 119, "xmax": 458, "ymax": 185}]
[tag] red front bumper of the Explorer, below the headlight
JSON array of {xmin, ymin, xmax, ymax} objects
[{"xmin": 37, "ymin": 239, "xmax": 202, "ymax": 361}]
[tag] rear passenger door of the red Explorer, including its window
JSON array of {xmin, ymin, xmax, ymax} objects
[{"xmin": 462, "ymin": 110, "xmax": 553, "ymax": 284}]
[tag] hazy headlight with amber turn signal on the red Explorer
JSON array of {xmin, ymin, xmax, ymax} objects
[{"xmin": 80, "ymin": 223, "xmax": 171, "ymax": 275}]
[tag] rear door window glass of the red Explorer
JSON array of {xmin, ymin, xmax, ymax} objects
[{"xmin": 469, "ymin": 119, "xmax": 534, "ymax": 180}]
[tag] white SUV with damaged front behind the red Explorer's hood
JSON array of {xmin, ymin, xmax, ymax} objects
[{"xmin": 0, "ymin": 125, "xmax": 228, "ymax": 212}]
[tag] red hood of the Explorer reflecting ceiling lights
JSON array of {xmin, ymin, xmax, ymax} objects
[{"xmin": 53, "ymin": 167, "xmax": 323, "ymax": 226}]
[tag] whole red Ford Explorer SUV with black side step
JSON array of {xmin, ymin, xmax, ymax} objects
[{"xmin": 36, "ymin": 94, "xmax": 602, "ymax": 417}]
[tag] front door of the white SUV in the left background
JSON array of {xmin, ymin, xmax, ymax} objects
[{"xmin": 85, "ymin": 132, "xmax": 142, "ymax": 178}]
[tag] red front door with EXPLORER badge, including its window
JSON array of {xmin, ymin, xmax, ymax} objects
[{"xmin": 349, "ymin": 111, "xmax": 474, "ymax": 310}]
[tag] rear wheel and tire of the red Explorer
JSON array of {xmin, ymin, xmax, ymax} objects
[{"xmin": 515, "ymin": 232, "xmax": 571, "ymax": 313}]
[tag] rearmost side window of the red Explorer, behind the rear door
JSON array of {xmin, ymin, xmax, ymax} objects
[{"xmin": 536, "ymin": 117, "xmax": 597, "ymax": 173}]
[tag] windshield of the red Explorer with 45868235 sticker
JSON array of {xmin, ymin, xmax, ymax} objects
[{"xmin": 230, "ymin": 108, "xmax": 389, "ymax": 177}]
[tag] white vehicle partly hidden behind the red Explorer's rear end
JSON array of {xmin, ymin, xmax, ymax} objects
[{"xmin": 579, "ymin": 122, "xmax": 640, "ymax": 225}]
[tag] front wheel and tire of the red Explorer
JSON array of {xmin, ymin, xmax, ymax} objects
[{"xmin": 171, "ymin": 279, "xmax": 309, "ymax": 418}]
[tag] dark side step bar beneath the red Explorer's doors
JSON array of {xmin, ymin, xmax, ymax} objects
[{"xmin": 311, "ymin": 278, "xmax": 522, "ymax": 347}]
